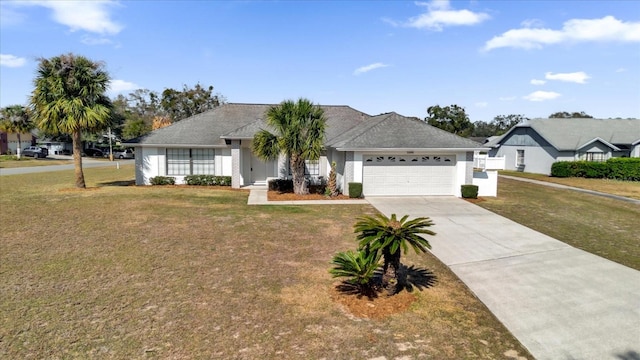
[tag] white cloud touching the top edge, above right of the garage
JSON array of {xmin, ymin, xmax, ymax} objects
[{"xmin": 389, "ymin": 0, "xmax": 490, "ymax": 31}]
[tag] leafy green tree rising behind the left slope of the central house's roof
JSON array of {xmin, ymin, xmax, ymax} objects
[{"xmin": 160, "ymin": 84, "xmax": 224, "ymax": 122}]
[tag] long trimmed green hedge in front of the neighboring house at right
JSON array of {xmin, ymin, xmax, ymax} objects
[{"xmin": 551, "ymin": 158, "xmax": 640, "ymax": 181}]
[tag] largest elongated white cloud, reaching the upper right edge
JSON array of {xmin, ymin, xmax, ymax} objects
[{"xmin": 484, "ymin": 16, "xmax": 640, "ymax": 51}]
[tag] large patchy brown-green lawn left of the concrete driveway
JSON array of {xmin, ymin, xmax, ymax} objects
[{"xmin": 0, "ymin": 165, "xmax": 531, "ymax": 359}]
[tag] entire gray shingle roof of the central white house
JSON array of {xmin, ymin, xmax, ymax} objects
[{"xmin": 127, "ymin": 103, "xmax": 481, "ymax": 149}]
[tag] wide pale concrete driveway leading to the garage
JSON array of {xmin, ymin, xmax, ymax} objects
[{"xmin": 367, "ymin": 197, "xmax": 640, "ymax": 360}]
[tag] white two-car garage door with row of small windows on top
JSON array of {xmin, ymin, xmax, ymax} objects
[{"xmin": 362, "ymin": 155, "xmax": 456, "ymax": 196}]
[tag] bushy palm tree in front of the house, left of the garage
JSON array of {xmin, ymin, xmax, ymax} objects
[{"xmin": 252, "ymin": 99, "xmax": 326, "ymax": 194}]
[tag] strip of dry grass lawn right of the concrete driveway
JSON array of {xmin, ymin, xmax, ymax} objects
[{"xmin": 478, "ymin": 178, "xmax": 640, "ymax": 270}]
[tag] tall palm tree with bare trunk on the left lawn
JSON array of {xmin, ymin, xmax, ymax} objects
[{"xmin": 31, "ymin": 54, "xmax": 113, "ymax": 188}]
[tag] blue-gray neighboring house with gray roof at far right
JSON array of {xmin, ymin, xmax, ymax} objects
[{"xmin": 485, "ymin": 118, "xmax": 640, "ymax": 175}]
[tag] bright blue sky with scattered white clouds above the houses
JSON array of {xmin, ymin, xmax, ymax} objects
[{"xmin": 0, "ymin": 0, "xmax": 640, "ymax": 121}]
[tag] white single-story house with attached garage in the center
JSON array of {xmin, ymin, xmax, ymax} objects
[{"xmin": 124, "ymin": 104, "xmax": 504, "ymax": 196}]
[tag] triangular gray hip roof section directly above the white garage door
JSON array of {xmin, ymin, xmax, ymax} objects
[{"xmin": 328, "ymin": 112, "xmax": 482, "ymax": 151}]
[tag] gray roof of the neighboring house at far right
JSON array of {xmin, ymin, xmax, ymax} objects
[{"xmin": 485, "ymin": 118, "xmax": 640, "ymax": 151}]
